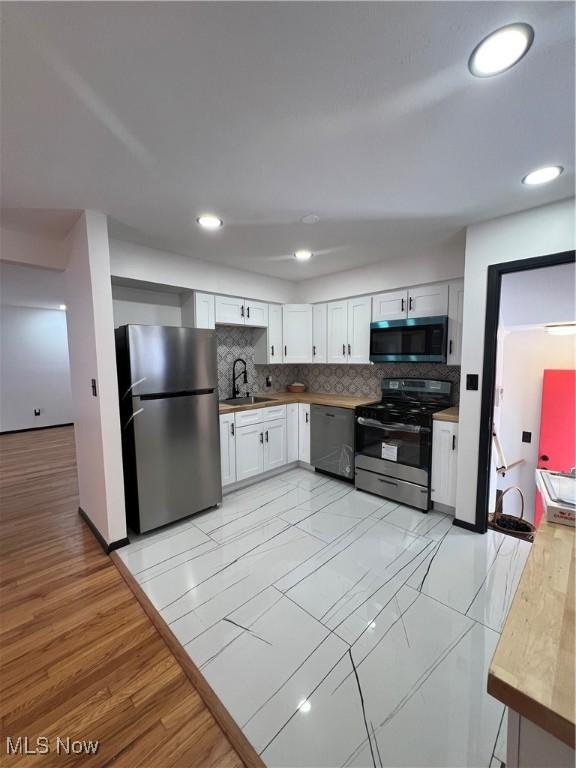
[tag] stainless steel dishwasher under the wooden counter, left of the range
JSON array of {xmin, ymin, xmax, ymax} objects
[{"xmin": 310, "ymin": 405, "xmax": 354, "ymax": 480}]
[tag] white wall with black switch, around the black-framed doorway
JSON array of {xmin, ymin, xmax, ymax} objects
[{"xmin": 456, "ymin": 199, "xmax": 576, "ymax": 524}]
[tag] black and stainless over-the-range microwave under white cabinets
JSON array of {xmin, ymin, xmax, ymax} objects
[{"xmin": 370, "ymin": 315, "xmax": 448, "ymax": 363}]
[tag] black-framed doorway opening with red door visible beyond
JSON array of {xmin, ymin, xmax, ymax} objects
[{"xmin": 476, "ymin": 251, "xmax": 576, "ymax": 532}]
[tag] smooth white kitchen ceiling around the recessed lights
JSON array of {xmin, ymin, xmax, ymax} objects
[{"xmin": 1, "ymin": 2, "xmax": 574, "ymax": 280}]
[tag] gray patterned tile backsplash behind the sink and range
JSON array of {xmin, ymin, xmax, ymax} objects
[{"xmin": 216, "ymin": 325, "xmax": 460, "ymax": 403}]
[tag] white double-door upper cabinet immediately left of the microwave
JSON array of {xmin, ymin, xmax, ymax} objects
[{"xmin": 327, "ymin": 296, "xmax": 371, "ymax": 363}]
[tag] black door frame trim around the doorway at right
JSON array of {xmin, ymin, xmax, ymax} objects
[{"xmin": 473, "ymin": 251, "xmax": 576, "ymax": 533}]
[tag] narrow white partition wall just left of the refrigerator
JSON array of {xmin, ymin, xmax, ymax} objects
[{"xmin": 66, "ymin": 211, "xmax": 126, "ymax": 543}]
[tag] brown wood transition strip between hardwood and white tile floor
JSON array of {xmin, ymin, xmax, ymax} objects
[{"xmin": 110, "ymin": 552, "xmax": 265, "ymax": 768}]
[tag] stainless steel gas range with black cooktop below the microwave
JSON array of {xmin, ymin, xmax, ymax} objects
[{"xmin": 355, "ymin": 379, "xmax": 452, "ymax": 512}]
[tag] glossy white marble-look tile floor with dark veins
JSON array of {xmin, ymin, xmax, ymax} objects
[{"xmin": 119, "ymin": 469, "xmax": 530, "ymax": 768}]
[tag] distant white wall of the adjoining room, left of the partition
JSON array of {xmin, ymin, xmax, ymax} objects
[{"xmin": 0, "ymin": 305, "xmax": 73, "ymax": 432}]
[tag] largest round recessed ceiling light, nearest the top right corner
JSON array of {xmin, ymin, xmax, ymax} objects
[{"xmin": 468, "ymin": 23, "xmax": 534, "ymax": 77}]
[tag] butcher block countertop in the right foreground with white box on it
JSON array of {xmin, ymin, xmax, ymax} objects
[{"xmin": 488, "ymin": 520, "xmax": 576, "ymax": 747}]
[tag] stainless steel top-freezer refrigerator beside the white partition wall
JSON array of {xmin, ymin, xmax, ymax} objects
[{"xmin": 116, "ymin": 325, "xmax": 222, "ymax": 533}]
